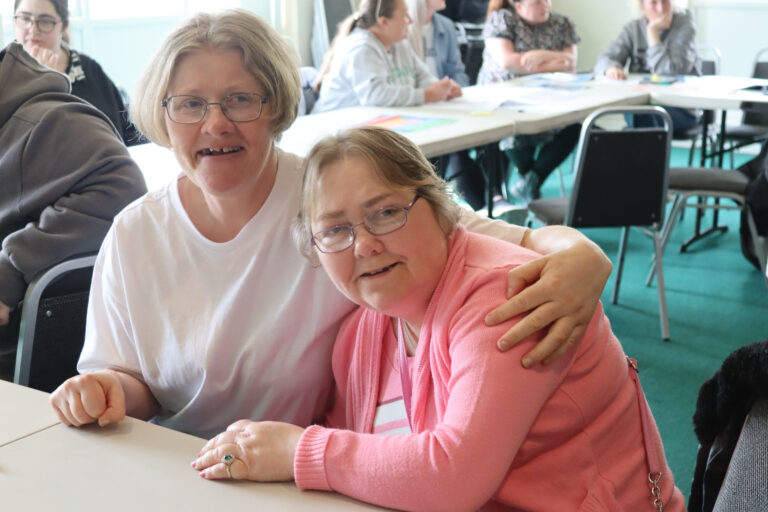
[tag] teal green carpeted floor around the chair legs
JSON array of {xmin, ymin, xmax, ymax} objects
[{"xmin": 543, "ymin": 148, "xmax": 768, "ymax": 499}]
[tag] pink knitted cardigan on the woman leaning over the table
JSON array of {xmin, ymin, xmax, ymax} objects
[{"xmin": 294, "ymin": 229, "xmax": 684, "ymax": 512}]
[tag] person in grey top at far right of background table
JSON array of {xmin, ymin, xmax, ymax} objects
[{"xmin": 595, "ymin": 0, "xmax": 701, "ymax": 132}]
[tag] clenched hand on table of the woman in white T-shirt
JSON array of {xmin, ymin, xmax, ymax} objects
[{"xmin": 51, "ymin": 370, "xmax": 125, "ymax": 427}]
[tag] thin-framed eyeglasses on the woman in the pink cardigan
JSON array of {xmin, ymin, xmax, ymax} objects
[{"xmin": 311, "ymin": 194, "xmax": 421, "ymax": 254}]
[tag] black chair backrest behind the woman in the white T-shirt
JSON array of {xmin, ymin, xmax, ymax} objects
[{"xmin": 14, "ymin": 255, "xmax": 96, "ymax": 392}]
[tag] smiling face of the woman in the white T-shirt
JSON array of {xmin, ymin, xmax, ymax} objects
[{"xmin": 165, "ymin": 49, "xmax": 275, "ymax": 197}]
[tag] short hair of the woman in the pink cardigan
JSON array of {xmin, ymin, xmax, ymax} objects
[{"xmin": 293, "ymin": 126, "xmax": 459, "ymax": 261}]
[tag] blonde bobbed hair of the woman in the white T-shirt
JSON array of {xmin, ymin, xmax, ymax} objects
[{"xmin": 131, "ymin": 9, "xmax": 301, "ymax": 147}]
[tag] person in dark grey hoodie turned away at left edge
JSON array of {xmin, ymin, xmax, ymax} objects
[{"xmin": 0, "ymin": 43, "xmax": 147, "ymax": 378}]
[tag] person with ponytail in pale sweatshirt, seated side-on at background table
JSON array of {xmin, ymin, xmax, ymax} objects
[{"xmin": 312, "ymin": 0, "xmax": 461, "ymax": 113}]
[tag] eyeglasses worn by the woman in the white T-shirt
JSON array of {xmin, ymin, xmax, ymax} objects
[{"xmin": 161, "ymin": 92, "xmax": 267, "ymax": 124}]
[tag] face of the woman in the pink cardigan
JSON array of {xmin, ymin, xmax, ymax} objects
[{"xmin": 311, "ymin": 156, "xmax": 448, "ymax": 325}]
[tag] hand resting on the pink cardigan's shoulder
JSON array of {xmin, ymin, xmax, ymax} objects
[{"xmin": 486, "ymin": 241, "xmax": 612, "ymax": 368}]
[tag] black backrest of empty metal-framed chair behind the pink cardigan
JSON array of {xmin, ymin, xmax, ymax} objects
[{"xmin": 565, "ymin": 107, "xmax": 672, "ymax": 227}]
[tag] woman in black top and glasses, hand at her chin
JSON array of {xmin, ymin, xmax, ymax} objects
[{"xmin": 13, "ymin": 0, "xmax": 146, "ymax": 146}]
